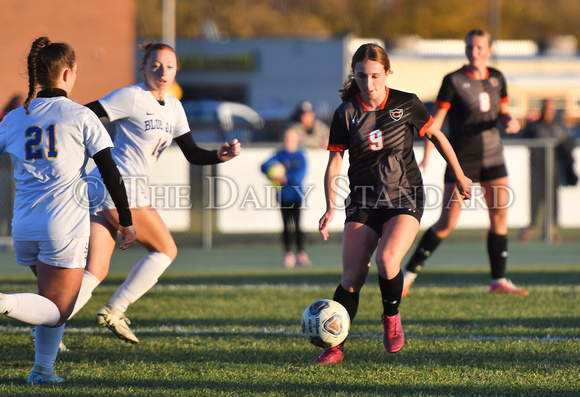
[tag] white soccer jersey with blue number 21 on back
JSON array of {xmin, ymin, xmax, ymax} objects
[{"xmin": 0, "ymin": 96, "xmax": 113, "ymax": 241}]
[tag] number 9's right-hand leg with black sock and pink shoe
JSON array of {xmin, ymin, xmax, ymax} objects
[{"xmin": 376, "ymin": 214, "xmax": 419, "ymax": 353}]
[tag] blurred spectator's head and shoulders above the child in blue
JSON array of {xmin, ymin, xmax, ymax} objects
[{"xmin": 292, "ymin": 101, "xmax": 330, "ymax": 149}]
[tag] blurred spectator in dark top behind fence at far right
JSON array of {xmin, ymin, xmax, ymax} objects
[{"xmin": 520, "ymin": 99, "xmax": 577, "ymax": 244}]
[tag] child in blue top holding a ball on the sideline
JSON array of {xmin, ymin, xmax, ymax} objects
[{"xmin": 261, "ymin": 127, "xmax": 311, "ymax": 269}]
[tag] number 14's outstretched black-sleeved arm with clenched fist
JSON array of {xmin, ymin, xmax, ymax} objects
[{"xmin": 175, "ymin": 132, "xmax": 241, "ymax": 165}]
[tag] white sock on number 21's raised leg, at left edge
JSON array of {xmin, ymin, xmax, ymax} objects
[{"xmin": 3, "ymin": 293, "xmax": 60, "ymax": 327}]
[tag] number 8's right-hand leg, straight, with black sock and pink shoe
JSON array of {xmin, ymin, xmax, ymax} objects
[{"xmin": 481, "ymin": 176, "xmax": 528, "ymax": 295}]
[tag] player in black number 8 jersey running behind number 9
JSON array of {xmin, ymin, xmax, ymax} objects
[{"xmin": 403, "ymin": 30, "xmax": 528, "ymax": 296}]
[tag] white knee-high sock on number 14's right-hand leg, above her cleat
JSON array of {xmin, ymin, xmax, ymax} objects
[{"xmin": 108, "ymin": 252, "xmax": 171, "ymax": 312}]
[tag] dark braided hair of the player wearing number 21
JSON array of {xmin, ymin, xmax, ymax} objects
[{"xmin": 24, "ymin": 37, "xmax": 77, "ymax": 114}]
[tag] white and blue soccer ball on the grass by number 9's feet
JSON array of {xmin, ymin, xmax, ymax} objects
[{"xmin": 302, "ymin": 299, "xmax": 350, "ymax": 348}]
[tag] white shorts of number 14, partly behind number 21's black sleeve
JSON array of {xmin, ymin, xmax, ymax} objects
[{"xmin": 85, "ymin": 169, "xmax": 151, "ymax": 215}]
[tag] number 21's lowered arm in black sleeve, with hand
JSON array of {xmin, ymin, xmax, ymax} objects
[{"xmin": 93, "ymin": 148, "xmax": 135, "ymax": 249}]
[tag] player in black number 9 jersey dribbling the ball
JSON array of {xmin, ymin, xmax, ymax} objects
[{"xmin": 315, "ymin": 44, "xmax": 472, "ymax": 365}]
